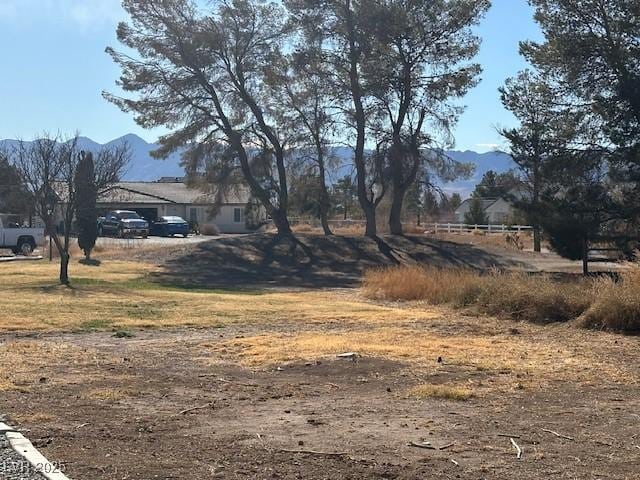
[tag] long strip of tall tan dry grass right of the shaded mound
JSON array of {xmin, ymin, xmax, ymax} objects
[{"xmin": 363, "ymin": 266, "xmax": 591, "ymax": 323}]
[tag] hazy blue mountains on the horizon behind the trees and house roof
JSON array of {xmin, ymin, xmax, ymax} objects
[{"xmin": 0, "ymin": 133, "xmax": 515, "ymax": 198}]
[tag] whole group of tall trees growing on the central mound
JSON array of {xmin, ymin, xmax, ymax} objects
[{"xmin": 105, "ymin": 0, "xmax": 489, "ymax": 236}]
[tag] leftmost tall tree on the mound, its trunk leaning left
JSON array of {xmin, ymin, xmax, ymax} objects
[{"xmin": 105, "ymin": 0, "xmax": 293, "ymax": 235}]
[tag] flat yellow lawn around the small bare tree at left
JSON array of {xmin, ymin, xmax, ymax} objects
[{"xmin": 0, "ymin": 261, "xmax": 436, "ymax": 332}]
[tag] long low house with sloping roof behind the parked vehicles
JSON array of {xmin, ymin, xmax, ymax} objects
[{"xmin": 55, "ymin": 177, "xmax": 266, "ymax": 233}]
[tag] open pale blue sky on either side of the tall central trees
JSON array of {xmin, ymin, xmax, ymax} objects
[{"xmin": 0, "ymin": 0, "xmax": 540, "ymax": 151}]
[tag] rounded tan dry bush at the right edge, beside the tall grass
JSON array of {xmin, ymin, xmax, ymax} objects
[{"xmin": 578, "ymin": 265, "xmax": 640, "ymax": 333}]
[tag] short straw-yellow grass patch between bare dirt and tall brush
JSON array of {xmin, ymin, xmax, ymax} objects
[{"xmin": 211, "ymin": 322, "xmax": 638, "ymax": 390}]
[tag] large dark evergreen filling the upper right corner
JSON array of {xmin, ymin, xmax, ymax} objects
[{"xmin": 521, "ymin": 0, "xmax": 640, "ymax": 216}]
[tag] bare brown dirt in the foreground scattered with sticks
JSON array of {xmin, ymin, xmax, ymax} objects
[{"xmin": 0, "ymin": 310, "xmax": 640, "ymax": 480}]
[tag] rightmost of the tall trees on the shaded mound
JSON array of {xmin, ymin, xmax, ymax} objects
[{"xmin": 364, "ymin": 0, "xmax": 489, "ymax": 235}]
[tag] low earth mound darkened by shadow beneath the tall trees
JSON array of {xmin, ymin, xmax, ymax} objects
[{"xmin": 151, "ymin": 234, "xmax": 522, "ymax": 289}]
